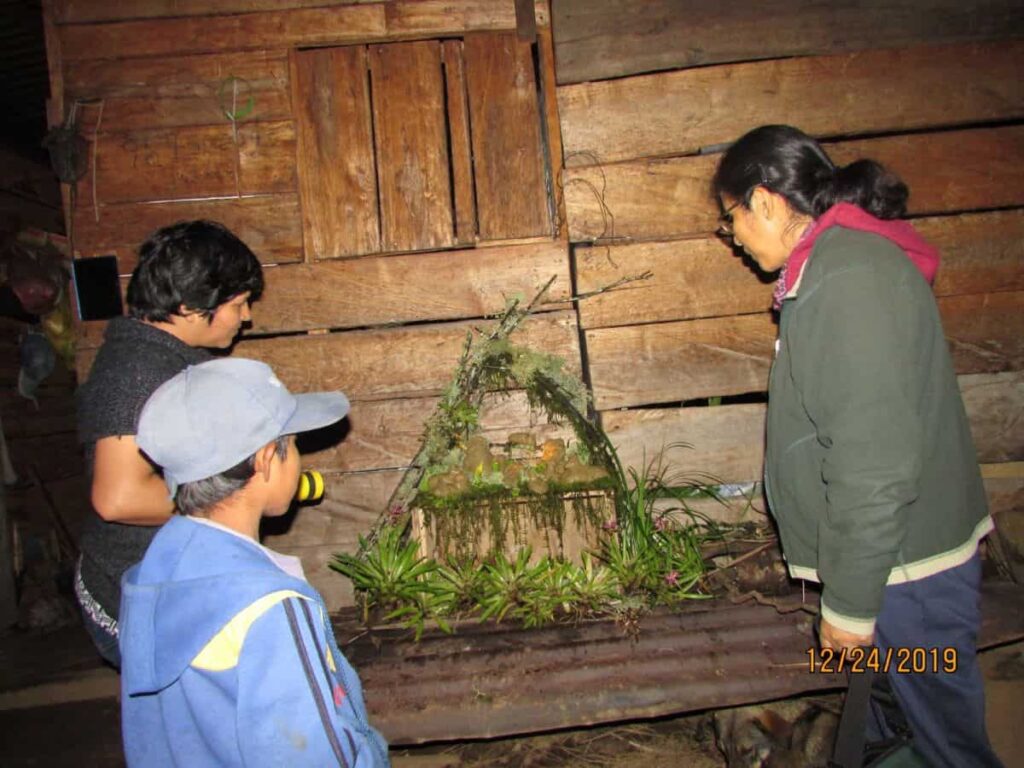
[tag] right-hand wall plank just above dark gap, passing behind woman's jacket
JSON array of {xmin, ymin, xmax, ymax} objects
[{"xmin": 585, "ymin": 291, "xmax": 1024, "ymax": 411}]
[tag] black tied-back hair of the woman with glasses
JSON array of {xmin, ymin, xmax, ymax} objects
[{"xmin": 712, "ymin": 125, "xmax": 909, "ymax": 219}]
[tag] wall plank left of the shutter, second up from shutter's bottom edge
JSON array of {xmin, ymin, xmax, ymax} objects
[{"xmin": 76, "ymin": 121, "xmax": 296, "ymax": 209}]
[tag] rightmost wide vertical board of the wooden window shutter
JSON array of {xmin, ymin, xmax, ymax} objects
[{"xmin": 464, "ymin": 33, "xmax": 551, "ymax": 240}]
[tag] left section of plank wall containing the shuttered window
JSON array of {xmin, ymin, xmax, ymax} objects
[{"xmin": 47, "ymin": 0, "xmax": 561, "ymax": 608}]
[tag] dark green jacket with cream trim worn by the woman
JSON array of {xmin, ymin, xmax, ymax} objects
[{"xmin": 765, "ymin": 226, "xmax": 992, "ymax": 634}]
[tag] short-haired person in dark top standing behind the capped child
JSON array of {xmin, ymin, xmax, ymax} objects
[{"xmin": 75, "ymin": 221, "xmax": 263, "ymax": 667}]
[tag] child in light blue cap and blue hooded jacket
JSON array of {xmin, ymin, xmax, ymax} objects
[{"xmin": 120, "ymin": 357, "xmax": 388, "ymax": 768}]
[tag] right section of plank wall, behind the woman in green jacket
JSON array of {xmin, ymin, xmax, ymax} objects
[{"xmin": 553, "ymin": 0, "xmax": 1024, "ymax": 528}]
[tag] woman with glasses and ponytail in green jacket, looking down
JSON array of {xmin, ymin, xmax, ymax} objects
[{"xmin": 713, "ymin": 125, "xmax": 999, "ymax": 768}]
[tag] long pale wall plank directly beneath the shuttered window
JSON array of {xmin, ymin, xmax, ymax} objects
[{"xmin": 246, "ymin": 242, "xmax": 571, "ymax": 333}]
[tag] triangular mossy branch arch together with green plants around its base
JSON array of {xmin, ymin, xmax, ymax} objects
[{"xmin": 331, "ymin": 284, "xmax": 714, "ymax": 637}]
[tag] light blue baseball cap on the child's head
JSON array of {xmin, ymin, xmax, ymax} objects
[{"xmin": 135, "ymin": 357, "xmax": 349, "ymax": 497}]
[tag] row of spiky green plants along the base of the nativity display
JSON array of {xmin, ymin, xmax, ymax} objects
[{"xmin": 331, "ymin": 450, "xmax": 719, "ymax": 638}]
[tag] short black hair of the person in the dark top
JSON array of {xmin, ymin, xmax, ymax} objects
[{"xmin": 128, "ymin": 220, "xmax": 263, "ymax": 323}]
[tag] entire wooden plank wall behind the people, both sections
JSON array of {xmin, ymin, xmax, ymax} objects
[{"xmin": 48, "ymin": 0, "xmax": 1024, "ymax": 606}]
